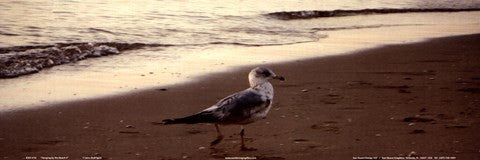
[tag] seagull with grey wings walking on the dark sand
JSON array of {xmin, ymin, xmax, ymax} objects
[{"xmin": 162, "ymin": 67, "xmax": 285, "ymax": 151}]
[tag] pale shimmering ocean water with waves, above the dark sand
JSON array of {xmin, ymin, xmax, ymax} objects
[{"xmin": 0, "ymin": 0, "xmax": 480, "ymax": 110}]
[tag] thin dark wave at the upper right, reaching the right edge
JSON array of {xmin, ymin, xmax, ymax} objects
[{"xmin": 265, "ymin": 8, "xmax": 480, "ymax": 20}]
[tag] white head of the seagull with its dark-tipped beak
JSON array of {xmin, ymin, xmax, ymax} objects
[{"xmin": 248, "ymin": 67, "xmax": 285, "ymax": 87}]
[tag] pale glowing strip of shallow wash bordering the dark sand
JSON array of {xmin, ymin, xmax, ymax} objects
[{"xmin": 0, "ymin": 12, "xmax": 480, "ymax": 112}]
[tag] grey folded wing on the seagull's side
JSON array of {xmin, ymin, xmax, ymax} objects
[{"xmin": 204, "ymin": 89, "xmax": 271, "ymax": 123}]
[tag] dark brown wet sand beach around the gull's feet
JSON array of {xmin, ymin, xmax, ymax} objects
[{"xmin": 0, "ymin": 35, "xmax": 480, "ymax": 160}]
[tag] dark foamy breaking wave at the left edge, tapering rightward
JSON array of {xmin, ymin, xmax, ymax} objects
[{"xmin": 0, "ymin": 42, "xmax": 318, "ymax": 78}]
